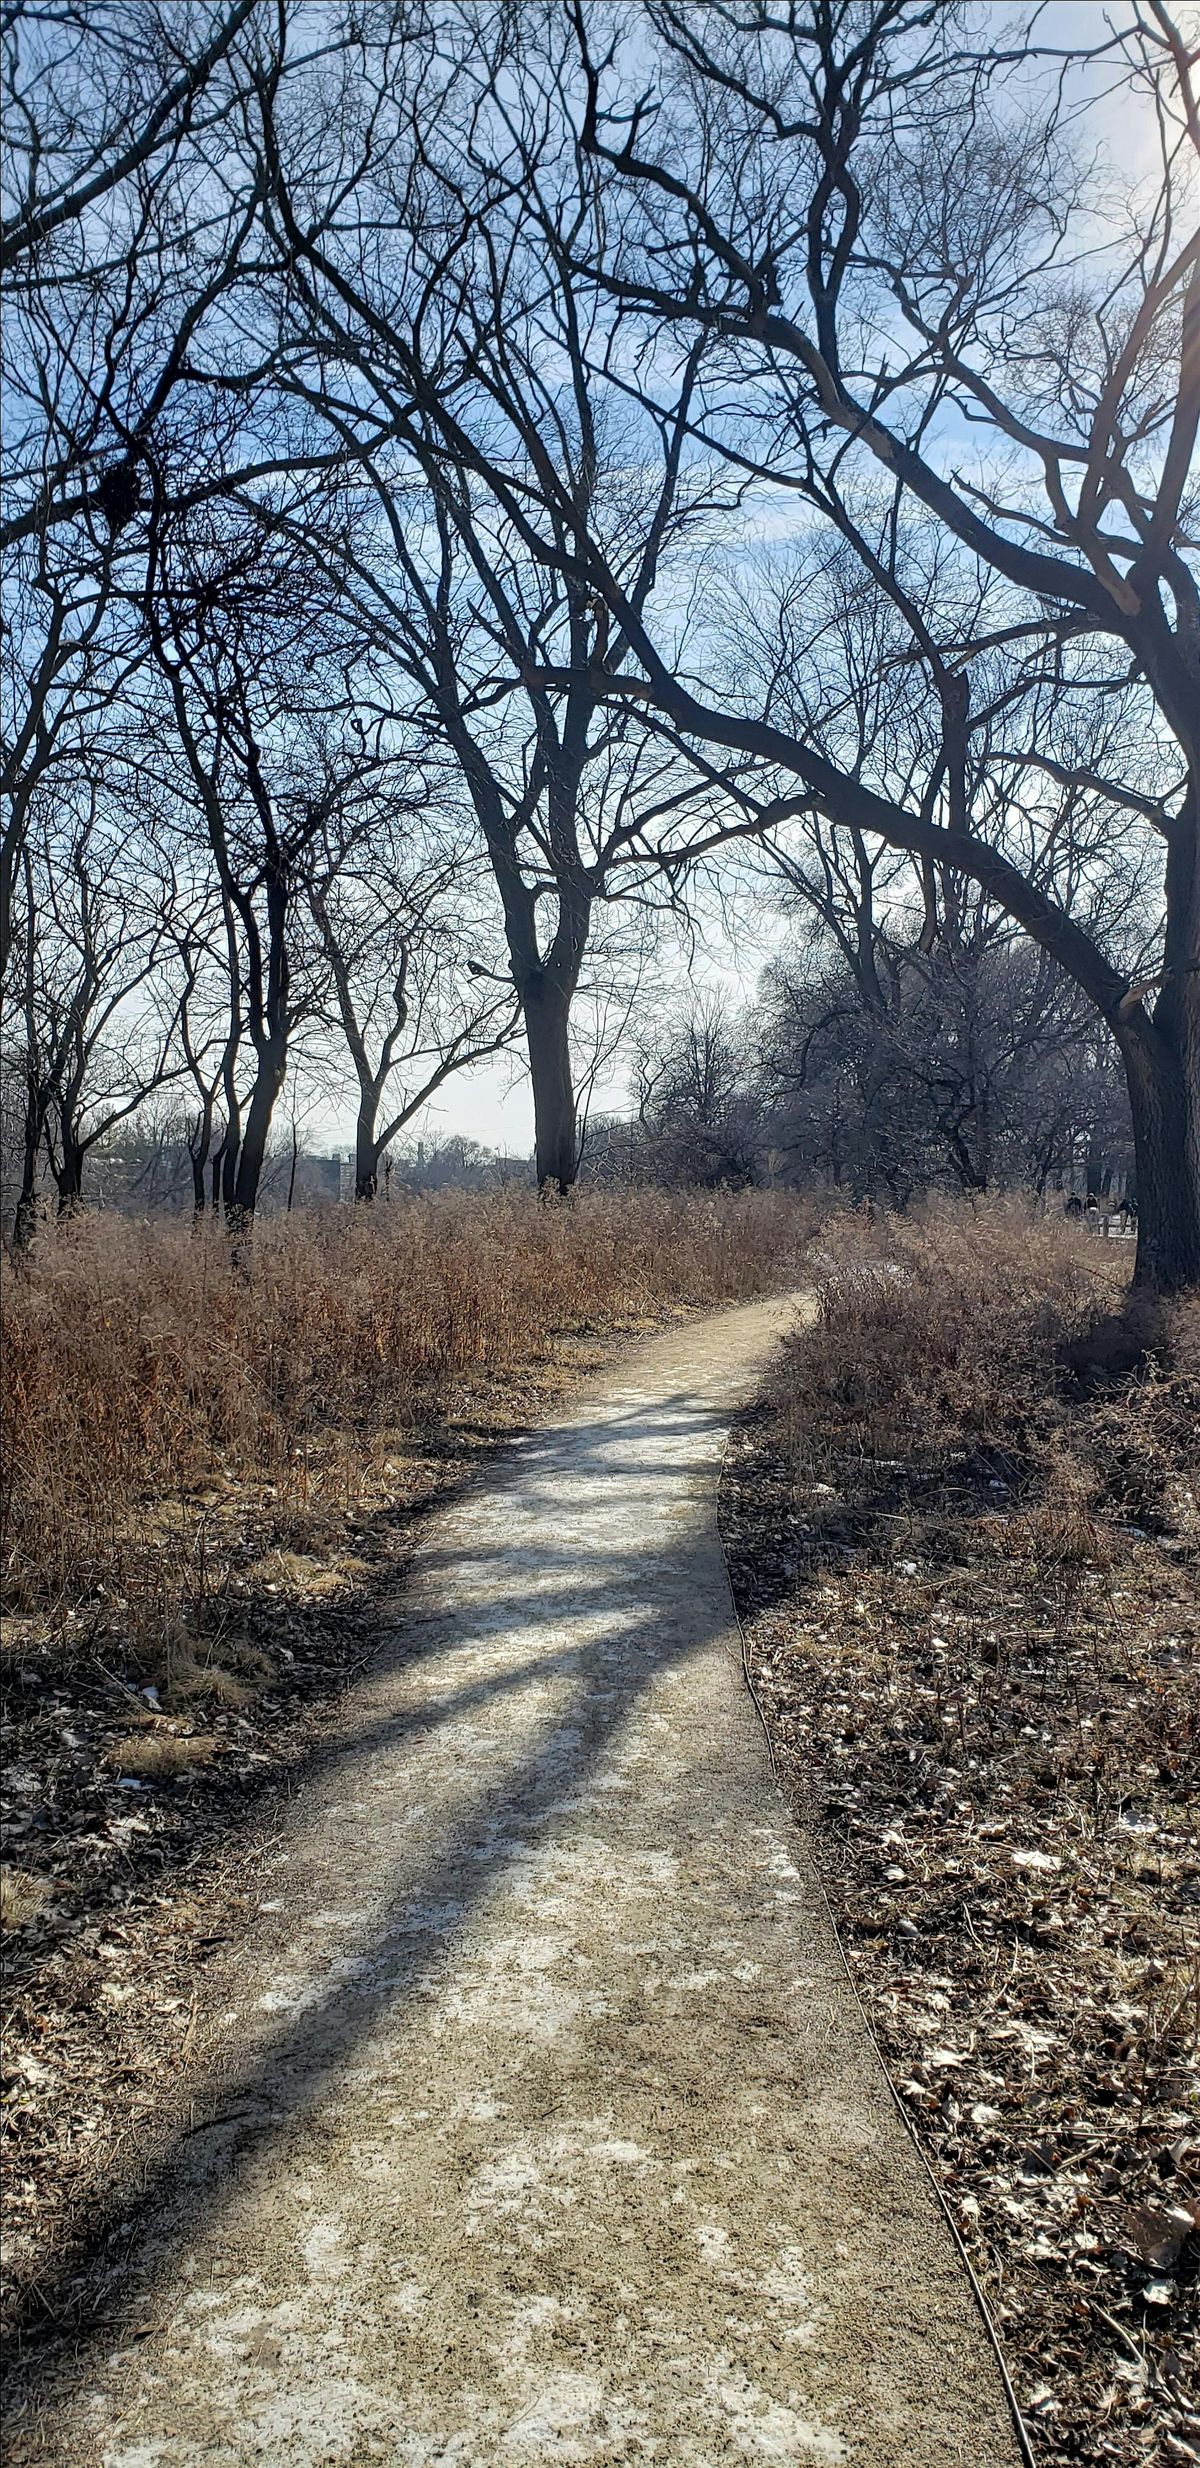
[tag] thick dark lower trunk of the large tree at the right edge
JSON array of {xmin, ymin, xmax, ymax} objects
[{"xmin": 1121, "ymin": 1014, "xmax": 1200, "ymax": 1293}]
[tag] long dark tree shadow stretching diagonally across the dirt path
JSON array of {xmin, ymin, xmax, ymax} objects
[{"xmin": 12, "ymin": 1394, "xmax": 728, "ymax": 2456}]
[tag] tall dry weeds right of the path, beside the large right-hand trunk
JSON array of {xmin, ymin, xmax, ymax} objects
[{"xmin": 780, "ymin": 1197, "xmax": 1200, "ymax": 1540}]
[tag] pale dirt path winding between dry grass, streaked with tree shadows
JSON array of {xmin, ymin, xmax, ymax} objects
[{"xmin": 37, "ymin": 1306, "xmax": 1015, "ymax": 2468}]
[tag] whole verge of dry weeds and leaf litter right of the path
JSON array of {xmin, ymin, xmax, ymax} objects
[{"xmin": 726, "ymin": 1207, "xmax": 1200, "ymax": 2468}]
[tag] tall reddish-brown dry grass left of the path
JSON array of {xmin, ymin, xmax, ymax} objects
[{"xmin": 2, "ymin": 1192, "xmax": 812, "ymax": 1696}]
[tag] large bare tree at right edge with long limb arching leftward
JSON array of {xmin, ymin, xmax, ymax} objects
[{"xmin": 573, "ymin": 0, "xmax": 1200, "ymax": 1288}]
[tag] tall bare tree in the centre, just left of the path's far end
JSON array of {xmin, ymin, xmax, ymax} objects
[{"xmin": 245, "ymin": 5, "xmax": 760, "ymax": 1192}]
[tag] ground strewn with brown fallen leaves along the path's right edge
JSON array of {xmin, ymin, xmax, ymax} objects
[{"xmin": 723, "ymin": 1409, "xmax": 1200, "ymax": 2468}]
